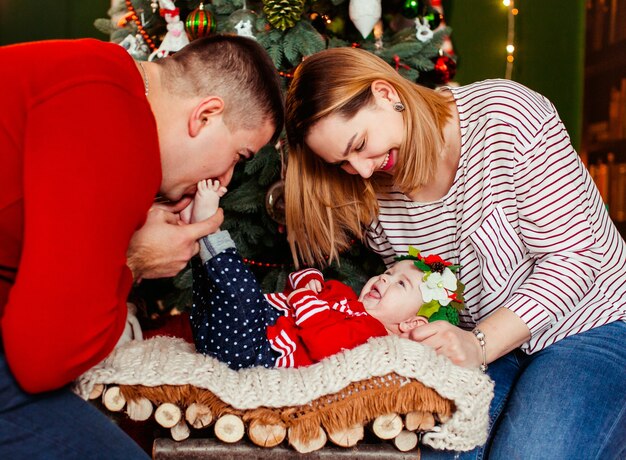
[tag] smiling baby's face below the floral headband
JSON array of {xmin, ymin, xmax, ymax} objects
[{"xmin": 359, "ymin": 260, "xmax": 424, "ymax": 332}]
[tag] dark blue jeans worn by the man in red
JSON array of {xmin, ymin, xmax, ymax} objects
[{"xmin": 0, "ymin": 349, "xmax": 149, "ymax": 460}]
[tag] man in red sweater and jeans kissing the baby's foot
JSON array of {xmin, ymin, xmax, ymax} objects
[{"xmin": 0, "ymin": 36, "xmax": 283, "ymax": 459}]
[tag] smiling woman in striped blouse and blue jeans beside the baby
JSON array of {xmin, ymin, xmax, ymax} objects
[{"xmin": 285, "ymin": 48, "xmax": 626, "ymax": 459}]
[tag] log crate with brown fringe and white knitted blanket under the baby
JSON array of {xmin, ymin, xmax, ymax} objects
[{"xmin": 76, "ymin": 336, "xmax": 493, "ymax": 453}]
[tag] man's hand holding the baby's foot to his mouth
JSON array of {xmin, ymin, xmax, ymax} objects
[{"xmin": 126, "ymin": 199, "xmax": 224, "ymax": 282}]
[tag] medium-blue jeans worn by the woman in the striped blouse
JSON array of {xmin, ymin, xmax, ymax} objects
[{"xmin": 422, "ymin": 321, "xmax": 626, "ymax": 460}]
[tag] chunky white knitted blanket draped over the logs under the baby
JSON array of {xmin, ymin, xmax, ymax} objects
[{"xmin": 75, "ymin": 336, "xmax": 493, "ymax": 450}]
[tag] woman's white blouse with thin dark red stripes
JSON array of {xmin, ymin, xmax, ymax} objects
[{"xmin": 367, "ymin": 80, "xmax": 626, "ymax": 354}]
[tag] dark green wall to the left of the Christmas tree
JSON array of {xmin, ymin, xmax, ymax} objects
[{"xmin": 0, "ymin": 0, "xmax": 111, "ymax": 45}]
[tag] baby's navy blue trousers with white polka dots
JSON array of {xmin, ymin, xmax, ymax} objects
[{"xmin": 190, "ymin": 248, "xmax": 281, "ymax": 369}]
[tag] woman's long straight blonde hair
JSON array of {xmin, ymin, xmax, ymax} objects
[{"xmin": 285, "ymin": 48, "xmax": 450, "ymax": 265}]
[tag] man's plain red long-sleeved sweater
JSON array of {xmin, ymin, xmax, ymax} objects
[{"xmin": 0, "ymin": 40, "xmax": 161, "ymax": 392}]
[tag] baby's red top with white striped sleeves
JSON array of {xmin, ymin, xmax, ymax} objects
[{"xmin": 267, "ymin": 280, "xmax": 387, "ymax": 367}]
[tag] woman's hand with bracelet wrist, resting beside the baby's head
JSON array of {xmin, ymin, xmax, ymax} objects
[{"xmin": 401, "ymin": 321, "xmax": 482, "ymax": 367}]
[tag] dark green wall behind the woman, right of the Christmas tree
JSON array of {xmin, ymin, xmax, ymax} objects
[{"xmin": 443, "ymin": 0, "xmax": 585, "ymax": 148}]
